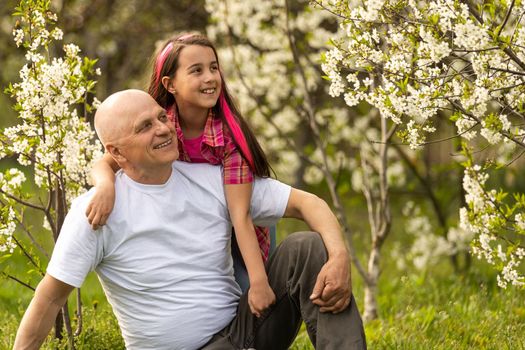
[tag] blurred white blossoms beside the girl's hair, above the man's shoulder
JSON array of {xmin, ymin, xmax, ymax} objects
[{"xmin": 206, "ymin": 0, "xmax": 352, "ymax": 184}]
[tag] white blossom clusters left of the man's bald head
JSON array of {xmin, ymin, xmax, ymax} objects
[{"xmin": 0, "ymin": 1, "xmax": 102, "ymax": 251}]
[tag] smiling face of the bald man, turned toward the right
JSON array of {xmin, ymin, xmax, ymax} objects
[{"xmin": 116, "ymin": 99, "xmax": 179, "ymax": 175}]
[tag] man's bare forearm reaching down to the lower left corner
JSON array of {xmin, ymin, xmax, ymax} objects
[{"xmin": 14, "ymin": 275, "xmax": 73, "ymax": 350}]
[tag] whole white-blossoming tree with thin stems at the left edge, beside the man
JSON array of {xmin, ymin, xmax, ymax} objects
[{"xmin": 0, "ymin": 0, "xmax": 102, "ymax": 344}]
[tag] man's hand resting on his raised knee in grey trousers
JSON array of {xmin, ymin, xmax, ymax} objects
[{"xmin": 310, "ymin": 254, "xmax": 352, "ymax": 314}]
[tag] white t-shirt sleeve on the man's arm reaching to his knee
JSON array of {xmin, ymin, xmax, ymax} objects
[{"xmin": 250, "ymin": 178, "xmax": 292, "ymax": 227}]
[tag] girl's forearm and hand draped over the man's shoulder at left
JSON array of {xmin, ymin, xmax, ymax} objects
[{"xmin": 86, "ymin": 153, "xmax": 120, "ymax": 230}]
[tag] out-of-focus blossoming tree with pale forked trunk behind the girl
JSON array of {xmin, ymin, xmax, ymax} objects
[{"xmin": 206, "ymin": 0, "xmax": 440, "ymax": 319}]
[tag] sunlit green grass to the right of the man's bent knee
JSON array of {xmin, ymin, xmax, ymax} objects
[{"xmin": 292, "ymin": 267, "xmax": 525, "ymax": 350}]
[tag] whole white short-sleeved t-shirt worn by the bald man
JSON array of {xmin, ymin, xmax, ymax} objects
[{"xmin": 47, "ymin": 162, "xmax": 290, "ymax": 349}]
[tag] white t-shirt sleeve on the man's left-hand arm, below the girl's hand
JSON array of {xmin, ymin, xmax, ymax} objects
[{"xmin": 47, "ymin": 196, "xmax": 102, "ymax": 288}]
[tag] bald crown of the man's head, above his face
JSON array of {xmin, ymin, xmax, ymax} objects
[{"xmin": 95, "ymin": 89, "xmax": 158, "ymax": 146}]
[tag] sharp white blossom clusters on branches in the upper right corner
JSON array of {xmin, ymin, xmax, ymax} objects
[{"xmin": 322, "ymin": 0, "xmax": 525, "ymax": 148}]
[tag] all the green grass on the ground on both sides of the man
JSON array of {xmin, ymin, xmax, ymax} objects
[{"xmin": 0, "ymin": 219, "xmax": 525, "ymax": 350}]
